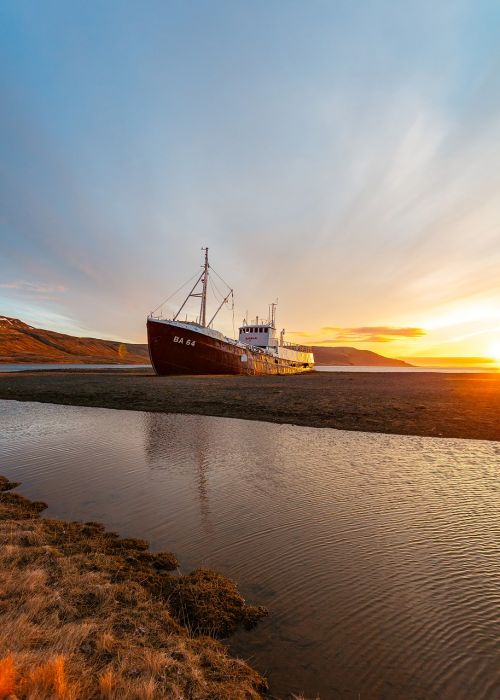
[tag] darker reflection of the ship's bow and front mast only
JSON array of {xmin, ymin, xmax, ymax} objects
[{"xmin": 144, "ymin": 413, "xmax": 215, "ymax": 534}]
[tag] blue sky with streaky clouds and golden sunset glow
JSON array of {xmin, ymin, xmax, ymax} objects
[{"xmin": 0, "ymin": 0, "xmax": 500, "ymax": 360}]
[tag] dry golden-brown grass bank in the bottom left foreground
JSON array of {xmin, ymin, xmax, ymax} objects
[{"xmin": 0, "ymin": 477, "xmax": 266, "ymax": 700}]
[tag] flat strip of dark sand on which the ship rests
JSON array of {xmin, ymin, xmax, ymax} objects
[{"xmin": 0, "ymin": 369, "xmax": 500, "ymax": 440}]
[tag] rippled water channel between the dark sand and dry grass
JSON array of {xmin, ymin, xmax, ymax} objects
[{"xmin": 0, "ymin": 401, "xmax": 500, "ymax": 700}]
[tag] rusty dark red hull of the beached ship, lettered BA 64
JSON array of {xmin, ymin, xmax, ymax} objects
[{"xmin": 147, "ymin": 318, "xmax": 314, "ymax": 376}]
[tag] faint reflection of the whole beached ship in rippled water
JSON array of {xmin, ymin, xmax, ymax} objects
[{"xmin": 143, "ymin": 413, "xmax": 290, "ymax": 535}]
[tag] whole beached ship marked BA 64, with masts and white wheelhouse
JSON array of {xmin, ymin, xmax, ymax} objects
[{"xmin": 147, "ymin": 248, "xmax": 314, "ymax": 375}]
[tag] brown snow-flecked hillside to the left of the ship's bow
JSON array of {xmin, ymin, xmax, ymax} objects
[{"xmin": 0, "ymin": 316, "xmax": 149, "ymax": 365}]
